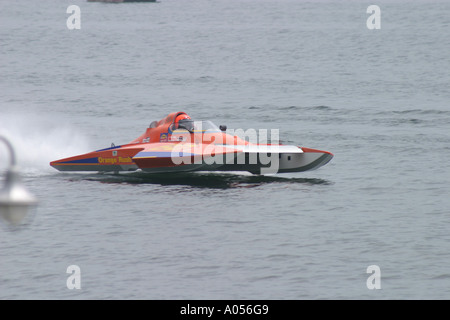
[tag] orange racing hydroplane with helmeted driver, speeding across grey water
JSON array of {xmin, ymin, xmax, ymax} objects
[{"xmin": 50, "ymin": 112, "xmax": 333, "ymax": 174}]
